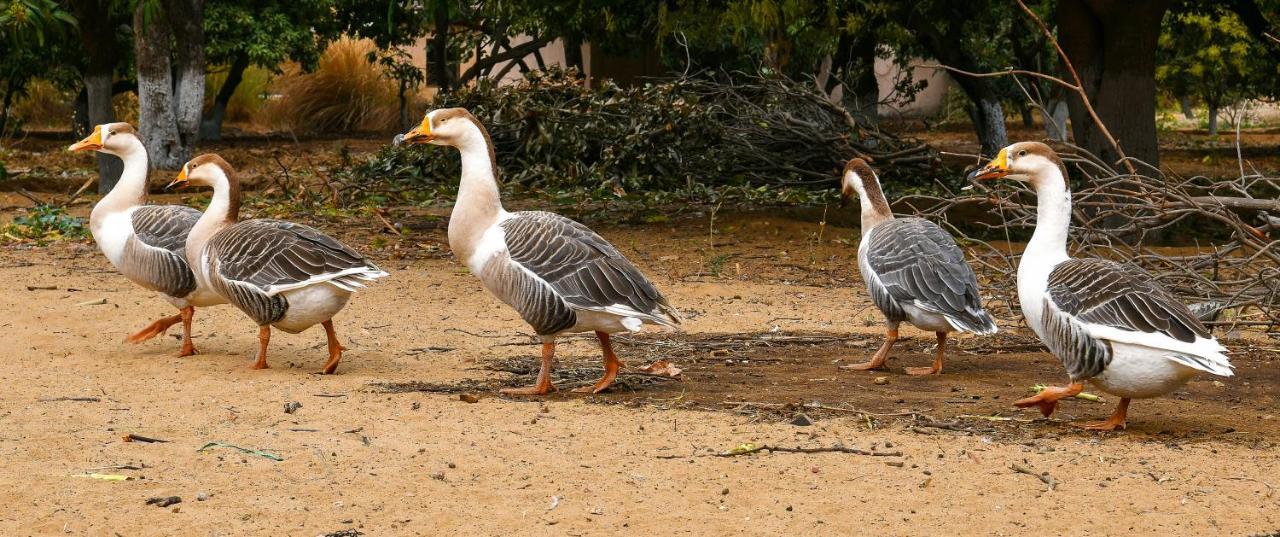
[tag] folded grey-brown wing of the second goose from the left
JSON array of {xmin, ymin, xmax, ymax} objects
[{"xmin": 207, "ymin": 220, "xmax": 387, "ymax": 294}]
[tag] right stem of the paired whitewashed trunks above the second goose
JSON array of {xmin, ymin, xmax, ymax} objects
[{"xmin": 165, "ymin": 0, "xmax": 205, "ymax": 161}]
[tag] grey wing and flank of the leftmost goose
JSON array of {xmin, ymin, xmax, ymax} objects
[{"xmin": 124, "ymin": 205, "xmax": 200, "ymax": 298}]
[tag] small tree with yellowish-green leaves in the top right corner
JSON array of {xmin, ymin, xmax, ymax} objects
[{"xmin": 1156, "ymin": 8, "xmax": 1277, "ymax": 136}]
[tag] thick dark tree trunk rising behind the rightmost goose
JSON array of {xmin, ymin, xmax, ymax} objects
[{"xmin": 1057, "ymin": 0, "xmax": 1169, "ymax": 166}]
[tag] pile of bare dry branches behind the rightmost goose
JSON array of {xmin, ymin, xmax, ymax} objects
[{"xmin": 902, "ymin": 144, "xmax": 1280, "ymax": 330}]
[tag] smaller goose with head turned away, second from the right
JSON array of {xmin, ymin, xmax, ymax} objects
[{"xmin": 841, "ymin": 159, "xmax": 997, "ymax": 375}]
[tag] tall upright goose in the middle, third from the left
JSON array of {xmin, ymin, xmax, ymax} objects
[{"xmin": 399, "ymin": 109, "xmax": 680, "ymax": 395}]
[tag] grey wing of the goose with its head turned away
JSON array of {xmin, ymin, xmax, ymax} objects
[{"xmin": 865, "ymin": 219, "xmax": 996, "ymax": 334}]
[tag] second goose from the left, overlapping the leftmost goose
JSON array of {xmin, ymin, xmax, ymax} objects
[{"xmin": 169, "ymin": 153, "xmax": 387, "ymax": 375}]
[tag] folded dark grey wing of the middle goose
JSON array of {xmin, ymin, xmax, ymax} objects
[{"xmin": 502, "ymin": 211, "xmax": 680, "ymax": 326}]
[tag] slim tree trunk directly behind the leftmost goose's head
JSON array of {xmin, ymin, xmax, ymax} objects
[{"xmin": 72, "ymin": 0, "xmax": 124, "ymax": 194}]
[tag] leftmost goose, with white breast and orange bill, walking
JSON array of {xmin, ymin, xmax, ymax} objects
[{"xmin": 68, "ymin": 123, "xmax": 225, "ymax": 357}]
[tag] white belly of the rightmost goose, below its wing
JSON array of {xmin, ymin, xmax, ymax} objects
[{"xmin": 1089, "ymin": 341, "xmax": 1198, "ymax": 399}]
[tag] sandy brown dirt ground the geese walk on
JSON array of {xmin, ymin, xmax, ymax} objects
[{"xmin": 0, "ymin": 202, "xmax": 1280, "ymax": 536}]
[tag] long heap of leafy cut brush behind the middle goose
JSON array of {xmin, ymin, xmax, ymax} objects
[{"xmin": 343, "ymin": 70, "xmax": 937, "ymax": 199}]
